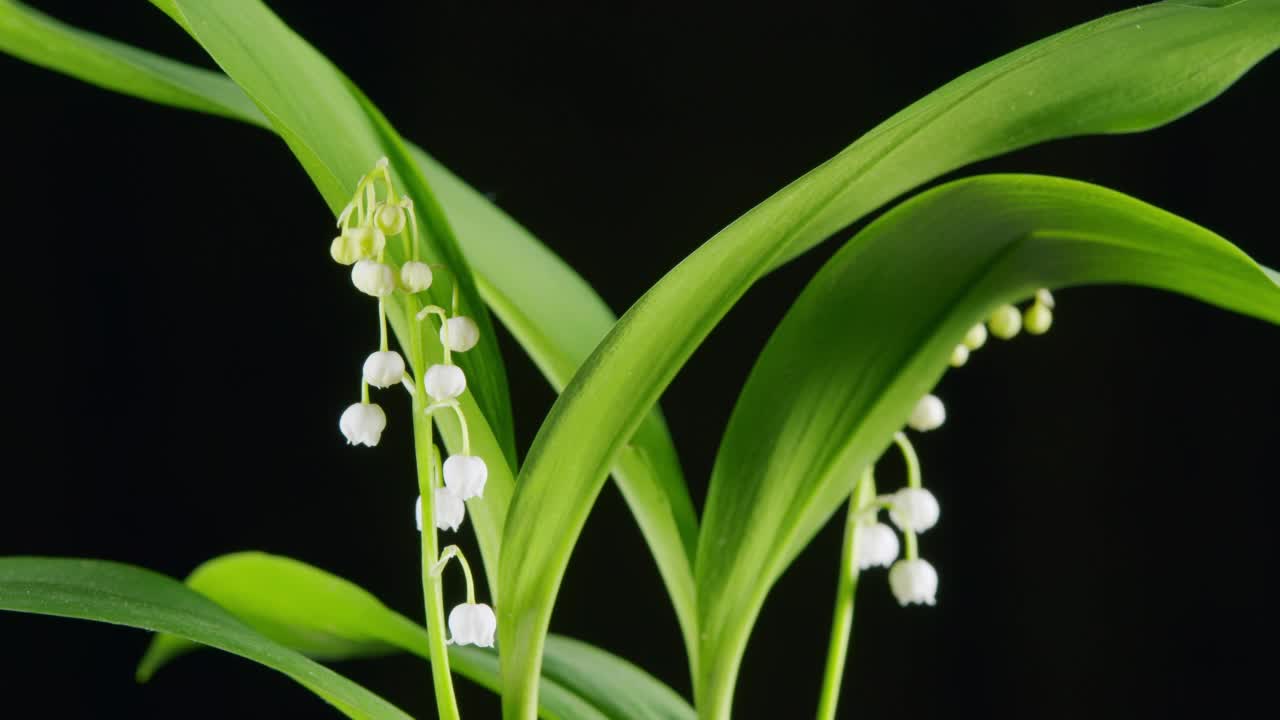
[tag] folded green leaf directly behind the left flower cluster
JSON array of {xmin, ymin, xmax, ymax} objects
[{"xmin": 138, "ymin": 0, "xmax": 515, "ymax": 587}]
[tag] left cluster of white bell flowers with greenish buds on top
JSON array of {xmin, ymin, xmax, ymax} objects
[{"xmin": 329, "ymin": 158, "xmax": 498, "ymax": 647}]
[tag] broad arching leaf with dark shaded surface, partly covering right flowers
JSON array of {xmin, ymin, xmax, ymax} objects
[{"xmin": 698, "ymin": 176, "xmax": 1280, "ymax": 716}]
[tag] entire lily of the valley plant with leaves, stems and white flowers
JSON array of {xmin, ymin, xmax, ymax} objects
[{"xmin": 0, "ymin": 0, "xmax": 1280, "ymax": 719}]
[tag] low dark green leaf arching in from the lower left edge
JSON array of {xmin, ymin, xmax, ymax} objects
[{"xmin": 0, "ymin": 557, "xmax": 410, "ymax": 720}]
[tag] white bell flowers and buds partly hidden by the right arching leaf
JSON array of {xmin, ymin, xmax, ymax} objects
[{"xmin": 852, "ymin": 290, "xmax": 1053, "ymax": 606}]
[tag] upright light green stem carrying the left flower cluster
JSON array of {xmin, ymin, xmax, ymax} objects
[{"xmin": 410, "ymin": 298, "xmax": 460, "ymax": 720}]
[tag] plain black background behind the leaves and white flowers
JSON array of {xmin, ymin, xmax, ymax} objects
[{"xmin": 0, "ymin": 0, "xmax": 1280, "ymax": 717}]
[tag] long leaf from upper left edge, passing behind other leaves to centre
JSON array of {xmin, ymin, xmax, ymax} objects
[{"xmin": 0, "ymin": 0, "xmax": 698, "ymax": 638}]
